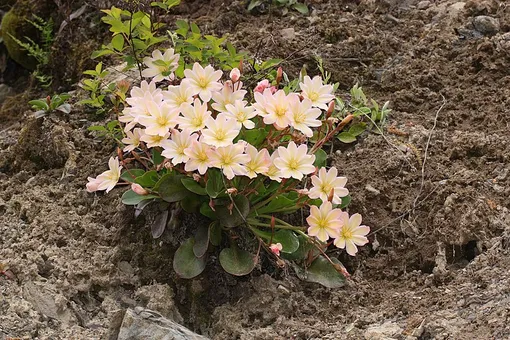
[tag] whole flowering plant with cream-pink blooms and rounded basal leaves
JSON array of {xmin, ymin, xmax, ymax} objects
[{"xmin": 87, "ymin": 50, "xmax": 370, "ymax": 287}]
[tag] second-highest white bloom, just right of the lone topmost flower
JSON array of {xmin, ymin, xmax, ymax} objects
[{"xmin": 184, "ymin": 63, "xmax": 222, "ymax": 102}]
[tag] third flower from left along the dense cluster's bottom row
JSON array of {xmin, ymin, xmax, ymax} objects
[{"xmin": 209, "ymin": 143, "xmax": 250, "ymax": 179}]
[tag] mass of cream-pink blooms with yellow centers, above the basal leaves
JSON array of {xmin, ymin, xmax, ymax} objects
[{"xmin": 87, "ymin": 49, "xmax": 369, "ymax": 264}]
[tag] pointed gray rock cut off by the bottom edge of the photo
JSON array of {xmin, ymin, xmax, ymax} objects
[{"xmin": 117, "ymin": 307, "xmax": 207, "ymax": 340}]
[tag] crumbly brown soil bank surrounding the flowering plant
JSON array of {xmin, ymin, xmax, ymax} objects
[{"xmin": 0, "ymin": 0, "xmax": 510, "ymax": 339}]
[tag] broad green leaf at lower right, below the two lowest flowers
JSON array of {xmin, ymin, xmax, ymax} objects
[{"xmin": 294, "ymin": 255, "xmax": 345, "ymax": 288}]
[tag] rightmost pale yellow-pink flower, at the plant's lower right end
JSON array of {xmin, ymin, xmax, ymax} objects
[{"xmin": 334, "ymin": 212, "xmax": 370, "ymax": 256}]
